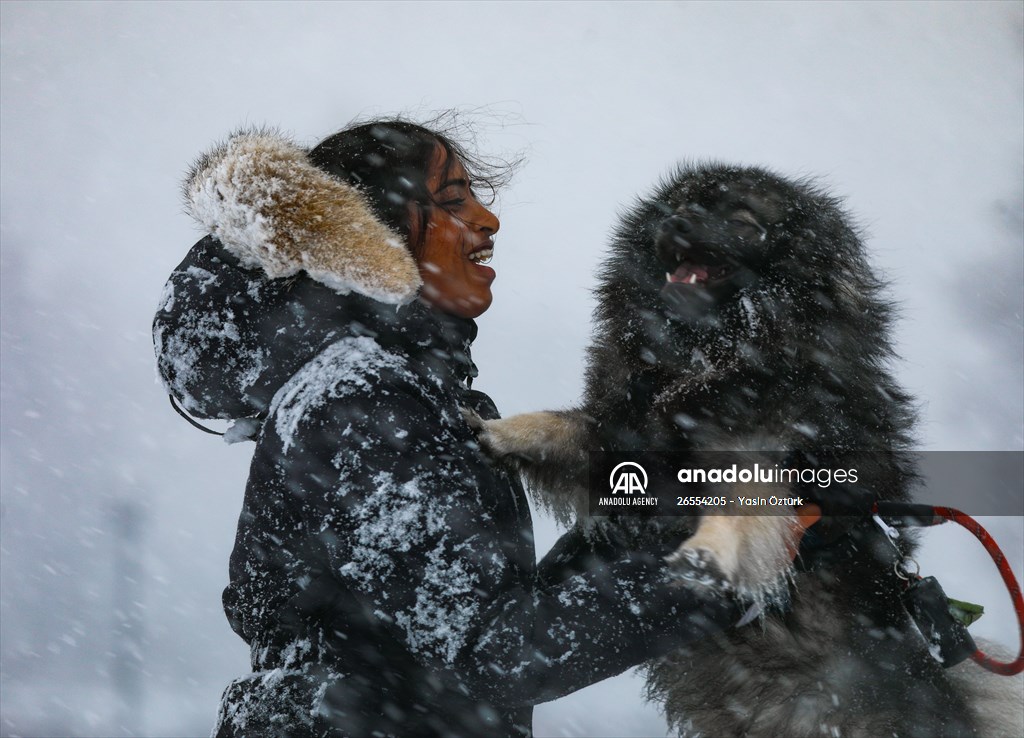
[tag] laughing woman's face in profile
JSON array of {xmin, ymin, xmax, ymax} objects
[{"xmin": 412, "ymin": 144, "xmax": 500, "ymax": 318}]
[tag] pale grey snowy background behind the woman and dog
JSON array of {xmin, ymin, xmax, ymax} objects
[{"xmin": 0, "ymin": 2, "xmax": 1024, "ymax": 736}]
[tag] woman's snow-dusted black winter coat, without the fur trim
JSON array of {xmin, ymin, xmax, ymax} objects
[{"xmin": 154, "ymin": 131, "xmax": 736, "ymax": 737}]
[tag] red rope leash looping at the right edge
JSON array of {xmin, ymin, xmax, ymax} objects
[{"xmin": 871, "ymin": 503, "xmax": 1024, "ymax": 677}]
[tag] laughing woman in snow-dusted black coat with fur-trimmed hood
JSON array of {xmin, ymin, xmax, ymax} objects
[{"xmin": 155, "ymin": 121, "xmax": 738, "ymax": 736}]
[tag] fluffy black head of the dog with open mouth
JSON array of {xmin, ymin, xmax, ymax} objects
[{"xmin": 598, "ymin": 164, "xmax": 885, "ymax": 374}]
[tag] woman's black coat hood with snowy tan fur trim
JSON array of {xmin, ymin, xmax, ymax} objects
[{"xmin": 153, "ymin": 132, "xmax": 475, "ymax": 420}]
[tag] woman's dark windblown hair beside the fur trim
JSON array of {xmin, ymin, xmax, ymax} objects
[{"xmin": 309, "ymin": 114, "xmax": 516, "ymax": 259}]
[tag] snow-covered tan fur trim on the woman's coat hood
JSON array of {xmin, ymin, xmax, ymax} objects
[{"xmin": 183, "ymin": 129, "xmax": 423, "ymax": 304}]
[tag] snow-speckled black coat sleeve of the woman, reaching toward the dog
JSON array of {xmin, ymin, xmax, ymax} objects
[{"xmin": 244, "ymin": 338, "xmax": 731, "ymax": 705}]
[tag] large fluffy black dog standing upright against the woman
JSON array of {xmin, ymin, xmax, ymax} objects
[{"xmin": 477, "ymin": 165, "xmax": 1022, "ymax": 737}]
